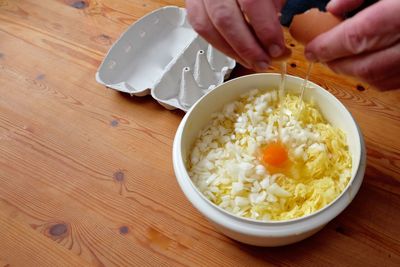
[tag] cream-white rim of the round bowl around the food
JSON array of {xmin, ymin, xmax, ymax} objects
[{"xmin": 173, "ymin": 73, "xmax": 366, "ymax": 234}]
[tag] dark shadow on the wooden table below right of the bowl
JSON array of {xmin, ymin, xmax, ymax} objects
[{"xmin": 236, "ymin": 164, "xmax": 400, "ymax": 265}]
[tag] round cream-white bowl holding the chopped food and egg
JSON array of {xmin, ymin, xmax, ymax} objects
[{"xmin": 173, "ymin": 74, "xmax": 366, "ymax": 246}]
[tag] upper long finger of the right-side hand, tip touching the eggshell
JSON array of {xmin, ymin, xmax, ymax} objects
[{"xmin": 305, "ymin": 0, "xmax": 400, "ymax": 62}]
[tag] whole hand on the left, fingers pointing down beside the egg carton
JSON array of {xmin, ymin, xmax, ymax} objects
[{"xmin": 186, "ymin": 0, "xmax": 290, "ymax": 71}]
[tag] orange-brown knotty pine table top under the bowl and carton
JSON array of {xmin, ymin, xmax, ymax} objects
[{"xmin": 0, "ymin": 0, "xmax": 400, "ymax": 266}]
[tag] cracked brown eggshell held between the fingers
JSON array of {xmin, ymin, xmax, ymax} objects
[{"xmin": 289, "ymin": 8, "xmax": 342, "ymax": 45}]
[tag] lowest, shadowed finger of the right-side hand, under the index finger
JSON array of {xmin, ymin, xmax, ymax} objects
[{"xmin": 328, "ymin": 43, "xmax": 400, "ymax": 89}]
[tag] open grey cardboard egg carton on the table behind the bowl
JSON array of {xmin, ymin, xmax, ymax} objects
[{"xmin": 96, "ymin": 6, "xmax": 236, "ymax": 111}]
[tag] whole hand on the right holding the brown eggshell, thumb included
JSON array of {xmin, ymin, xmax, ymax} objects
[{"xmin": 305, "ymin": 0, "xmax": 400, "ymax": 90}]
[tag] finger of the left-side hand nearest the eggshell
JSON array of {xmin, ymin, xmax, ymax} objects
[{"xmin": 238, "ymin": 0, "xmax": 285, "ymax": 58}]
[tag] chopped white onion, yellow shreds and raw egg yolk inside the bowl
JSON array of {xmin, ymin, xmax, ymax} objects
[{"xmin": 187, "ymin": 89, "xmax": 351, "ymax": 221}]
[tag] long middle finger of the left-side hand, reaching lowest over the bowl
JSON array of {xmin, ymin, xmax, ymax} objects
[{"xmin": 204, "ymin": 0, "xmax": 270, "ymax": 71}]
